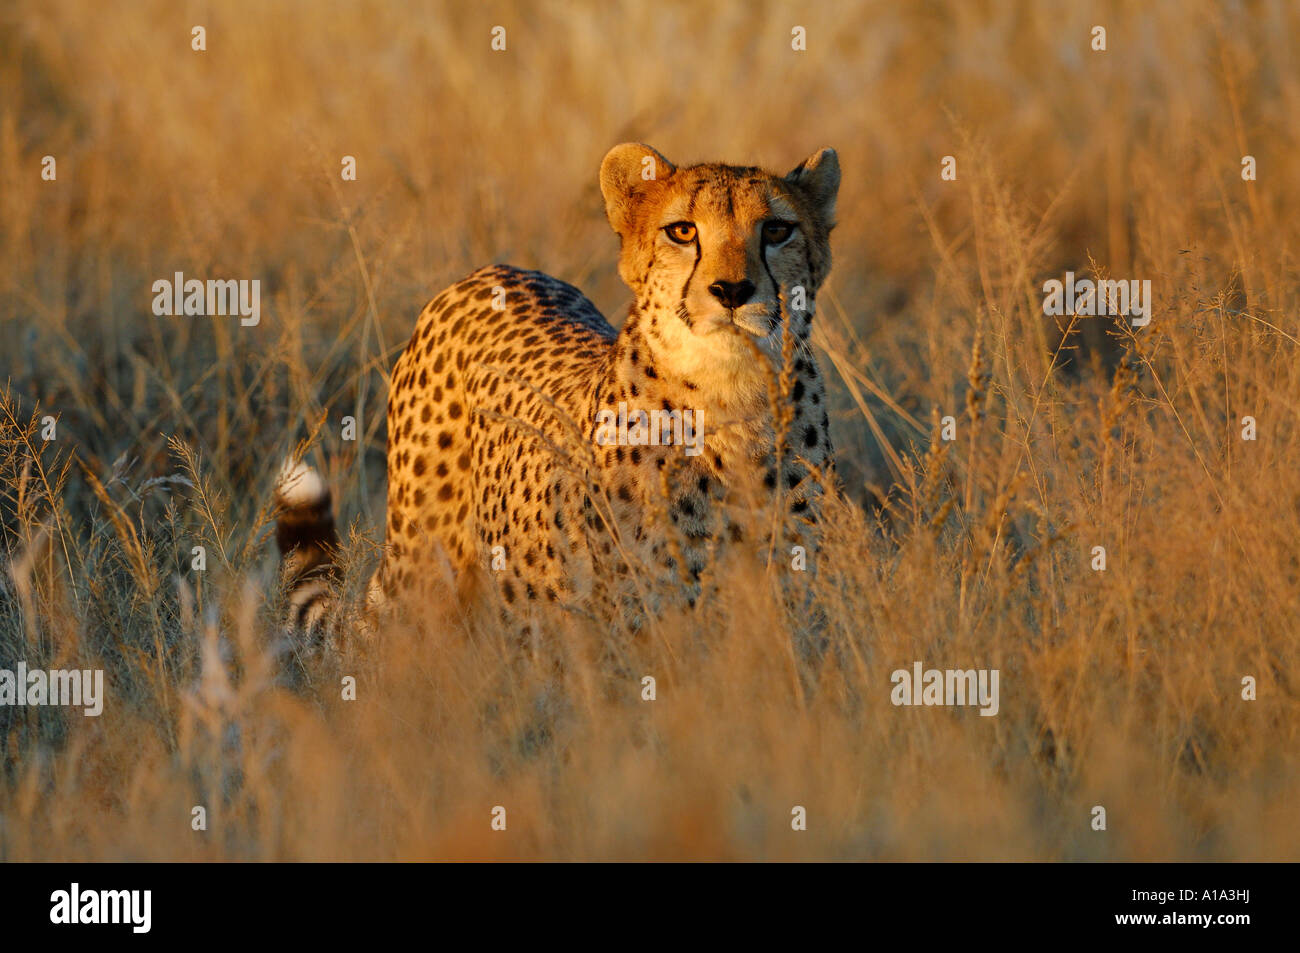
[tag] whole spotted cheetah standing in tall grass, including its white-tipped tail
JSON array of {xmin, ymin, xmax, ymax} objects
[{"xmin": 277, "ymin": 143, "xmax": 840, "ymax": 625}]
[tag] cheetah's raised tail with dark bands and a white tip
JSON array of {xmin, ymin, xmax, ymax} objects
[{"xmin": 276, "ymin": 460, "xmax": 339, "ymax": 632}]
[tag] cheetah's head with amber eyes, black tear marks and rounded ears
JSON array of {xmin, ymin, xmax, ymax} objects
[{"xmin": 601, "ymin": 143, "xmax": 840, "ymax": 369}]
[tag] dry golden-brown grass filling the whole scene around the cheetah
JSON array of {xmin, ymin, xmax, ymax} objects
[{"xmin": 0, "ymin": 0, "xmax": 1300, "ymax": 861}]
